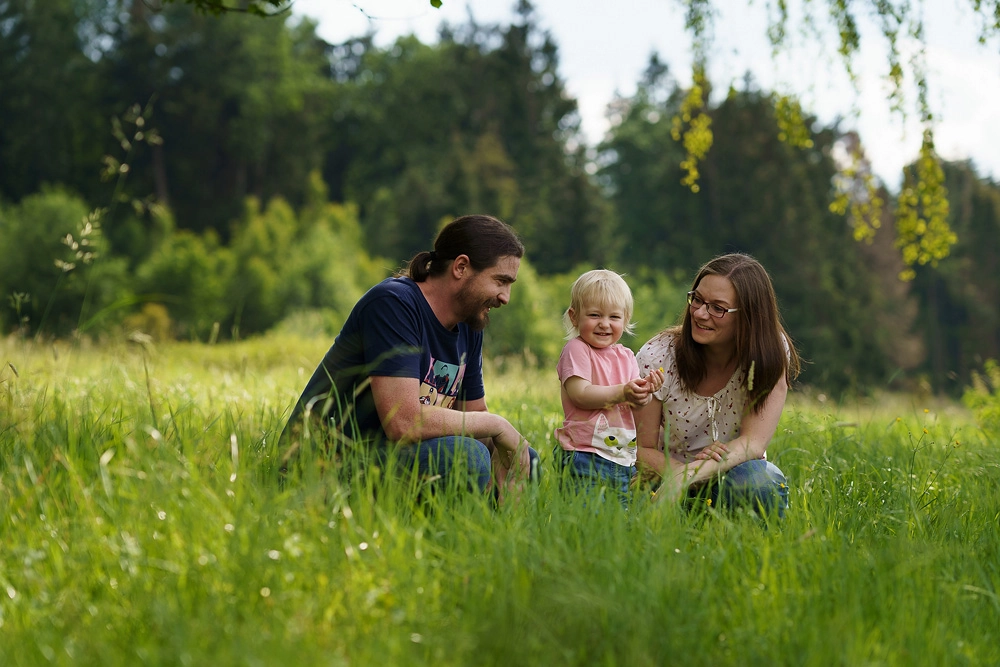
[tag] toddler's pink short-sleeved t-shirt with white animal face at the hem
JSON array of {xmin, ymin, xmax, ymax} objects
[{"xmin": 555, "ymin": 337, "xmax": 639, "ymax": 466}]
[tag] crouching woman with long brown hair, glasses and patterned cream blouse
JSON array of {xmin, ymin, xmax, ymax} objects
[{"xmin": 636, "ymin": 254, "xmax": 799, "ymax": 516}]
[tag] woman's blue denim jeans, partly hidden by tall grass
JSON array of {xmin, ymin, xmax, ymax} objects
[{"xmin": 688, "ymin": 459, "xmax": 788, "ymax": 518}]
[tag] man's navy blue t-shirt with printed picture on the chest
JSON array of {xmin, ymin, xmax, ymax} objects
[{"xmin": 286, "ymin": 278, "xmax": 486, "ymax": 438}]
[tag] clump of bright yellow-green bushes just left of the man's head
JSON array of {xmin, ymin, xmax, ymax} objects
[{"xmin": 137, "ymin": 175, "xmax": 389, "ymax": 338}]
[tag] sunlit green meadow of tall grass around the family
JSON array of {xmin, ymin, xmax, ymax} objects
[{"xmin": 0, "ymin": 336, "xmax": 1000, "ymax": 666}]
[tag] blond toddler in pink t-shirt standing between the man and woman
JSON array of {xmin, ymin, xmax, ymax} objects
[{"xmin": 555, "ymin": 269, "xmax": 663, "ymax": 504}]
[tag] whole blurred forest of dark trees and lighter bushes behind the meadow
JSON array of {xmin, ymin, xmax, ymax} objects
[{"xmin": 0, "ymin": 0, "xmax": 1000, "ymax": 395}]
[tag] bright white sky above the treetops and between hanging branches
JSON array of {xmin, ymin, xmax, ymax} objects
[{"xmin": 292, "ymin": 0, "xmax": 1000, "ymax": 190}]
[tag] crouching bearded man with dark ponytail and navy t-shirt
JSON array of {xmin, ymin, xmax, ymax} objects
[{"xmin": 281, "ymin": 215, "xmax": 537, "ymax": 491}]
